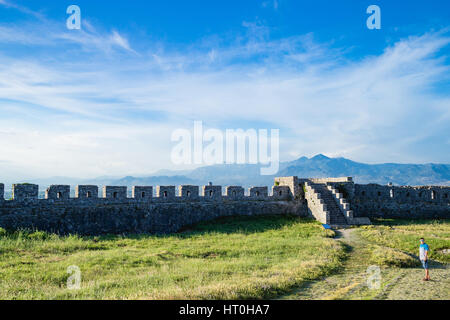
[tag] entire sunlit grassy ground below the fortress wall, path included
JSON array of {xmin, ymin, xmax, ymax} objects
[{"xmin": 0, "ymin": 216, "xmax": 450, "ymax": 300}]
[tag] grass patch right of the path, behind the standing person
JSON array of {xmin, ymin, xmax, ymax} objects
[{"xmin": 360, "ymin": 219, "xmax": 450, "ymax": 263}]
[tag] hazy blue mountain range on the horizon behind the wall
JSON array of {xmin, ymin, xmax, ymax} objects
[{"xmin": 5, "ymin": 155, "xmax": 450, "ymax": 190}]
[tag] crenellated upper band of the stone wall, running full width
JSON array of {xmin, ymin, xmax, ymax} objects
[{"xmin": 0, "ymin": 177, "xmax": 450, "ymax": 203}]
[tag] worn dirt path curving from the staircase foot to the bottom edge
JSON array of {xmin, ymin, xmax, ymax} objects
[{"xmin": 281, "ymin": 229, "xmax": 450, "ymax": 300}]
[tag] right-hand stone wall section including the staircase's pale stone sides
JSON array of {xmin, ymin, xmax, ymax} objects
[{"xmin": 275, "ymin": 177, "xmax": 450, "ymax": 224}]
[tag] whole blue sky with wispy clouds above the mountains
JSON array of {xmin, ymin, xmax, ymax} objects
[{"xmin": 0, "ymin": 0, "xmax": 450, "ymax": 179}]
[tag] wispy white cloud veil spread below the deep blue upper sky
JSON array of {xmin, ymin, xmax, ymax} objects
[{"xmin": 0, "ymin": 1, "xmax": 450, "ymax": 176}]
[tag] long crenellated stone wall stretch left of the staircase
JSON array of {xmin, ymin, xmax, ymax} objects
[{"xmin": 0, "ymin": 184, "xmax": 308, "ymax": 235}]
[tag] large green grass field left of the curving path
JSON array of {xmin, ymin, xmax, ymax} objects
[{"xmin": 0, "ymin": 216, "xmax": 345, "ymax": 299}]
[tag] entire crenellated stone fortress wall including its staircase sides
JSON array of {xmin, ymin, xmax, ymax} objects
[{"xmin": 0, "ymin": 177, "xmax": 450, "ymax": 235}]
